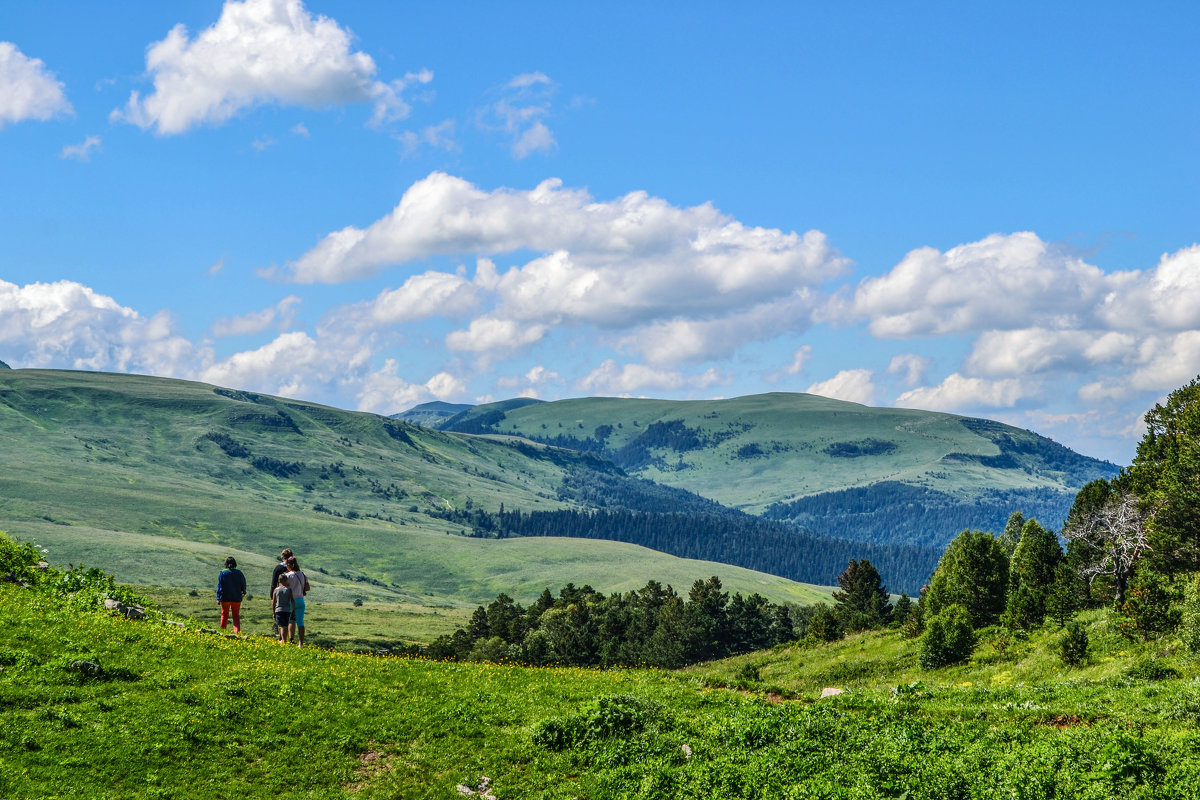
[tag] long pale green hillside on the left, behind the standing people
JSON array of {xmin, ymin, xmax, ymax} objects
[{"xmin": 0, "ymin": 369, "xmax": 828, "ymax": 607}]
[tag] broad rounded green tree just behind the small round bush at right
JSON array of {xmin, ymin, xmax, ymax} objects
[{"xmin": 924, "ymin": 530, "xmax": 1008, "ymax": 627}]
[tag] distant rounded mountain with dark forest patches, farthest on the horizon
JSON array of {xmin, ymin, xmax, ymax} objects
[{"xmin": 432, "ymin": 393, "xmax": 1118, "ymax": 547}]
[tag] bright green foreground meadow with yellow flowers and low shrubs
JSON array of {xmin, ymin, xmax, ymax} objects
[{"xmin": 0, "ymin": 584, "xmax": 1200, "ymax": 800}]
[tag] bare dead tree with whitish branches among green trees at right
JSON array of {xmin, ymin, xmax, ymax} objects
[{"xmin": 1062, "ymin": 493, "xmax": 1151, "ymax": 608}]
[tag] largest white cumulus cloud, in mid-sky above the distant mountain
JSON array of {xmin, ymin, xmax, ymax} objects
[{"xmin": 277, "ymin": 173, "xmax": 847, "ymax": 363}]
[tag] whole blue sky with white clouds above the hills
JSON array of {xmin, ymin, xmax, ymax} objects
[{"xmin": 0, "ymin": 0, "xmax": 1200, "ymax": 463}]
